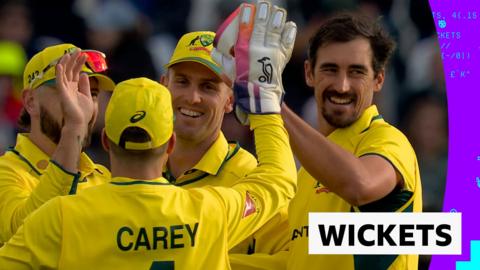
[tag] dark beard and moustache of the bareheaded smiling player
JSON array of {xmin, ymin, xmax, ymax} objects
[{"xmin": 322, "ymin": 90, "xmax": 359, "ymax": 128}]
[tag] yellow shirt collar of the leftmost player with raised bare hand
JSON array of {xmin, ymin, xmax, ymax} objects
[{"xmin": 11, "ymin": 133, "xmax": 96, "ymax": 176}]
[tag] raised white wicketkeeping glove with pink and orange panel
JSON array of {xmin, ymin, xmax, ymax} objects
[{"xmin": 212, "ymin": 1, "xmax": 297, "ymax": 124}]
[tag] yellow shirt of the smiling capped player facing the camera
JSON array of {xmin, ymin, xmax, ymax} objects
[{"xmin": 164, "ymin": 132, "xmax": 289, "ymax": 262}]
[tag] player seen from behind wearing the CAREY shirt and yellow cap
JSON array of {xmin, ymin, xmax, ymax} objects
[{"xmin": 0, "ymin": 3, "xmax": 296, "ymax": 269}]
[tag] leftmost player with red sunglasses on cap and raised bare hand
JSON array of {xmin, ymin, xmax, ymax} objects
[{"xmin": 0, "ymin": 44, "xmax": 115, "ymax": 246}]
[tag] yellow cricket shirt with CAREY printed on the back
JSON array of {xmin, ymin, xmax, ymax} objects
[{"xmin": 0, "ymin": 115, "xmax": 296, "ymax": 270}]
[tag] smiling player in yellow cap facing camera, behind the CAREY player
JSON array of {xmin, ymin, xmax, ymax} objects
[{"xmin": 161, "ymin": 26, "xmax": 289, "ymax": 258}]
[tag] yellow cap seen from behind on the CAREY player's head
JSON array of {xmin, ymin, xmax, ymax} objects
[{"xmin": 105, "ymin": 78, "xmax": 173, "ymax": 150}]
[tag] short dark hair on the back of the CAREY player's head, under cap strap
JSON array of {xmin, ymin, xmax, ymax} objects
[{"xmin": 110, "ymin": 127, "xmax": 168, "ymax": 160}]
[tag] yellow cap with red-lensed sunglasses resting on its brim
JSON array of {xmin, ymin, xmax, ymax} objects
[{"xmin": 23, "ymin": 44, "xmax": 115, "ymax": 91}]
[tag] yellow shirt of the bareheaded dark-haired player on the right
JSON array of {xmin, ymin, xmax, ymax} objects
[{"xmin": 288, "ymin": 106, "xmax": 422, "ymax": 270}]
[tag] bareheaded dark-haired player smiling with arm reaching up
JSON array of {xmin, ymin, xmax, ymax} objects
[{"xmin": 282, "ymin": 14, "xmax": 422, "ymax": 270}]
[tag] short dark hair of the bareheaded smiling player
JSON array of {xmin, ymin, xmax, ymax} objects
[{"xmin": 308, "ymin": 13, "xmax": 395, "ymax": 76}]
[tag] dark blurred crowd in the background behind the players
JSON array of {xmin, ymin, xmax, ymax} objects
[{"xmin": 0, "ymin": 0, "xmax": 448, "ymax": 262}]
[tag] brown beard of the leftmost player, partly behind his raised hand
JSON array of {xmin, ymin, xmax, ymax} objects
[{"xmin": 40, "ymin": 106, "xmax": 93, "ymax": 151}]
